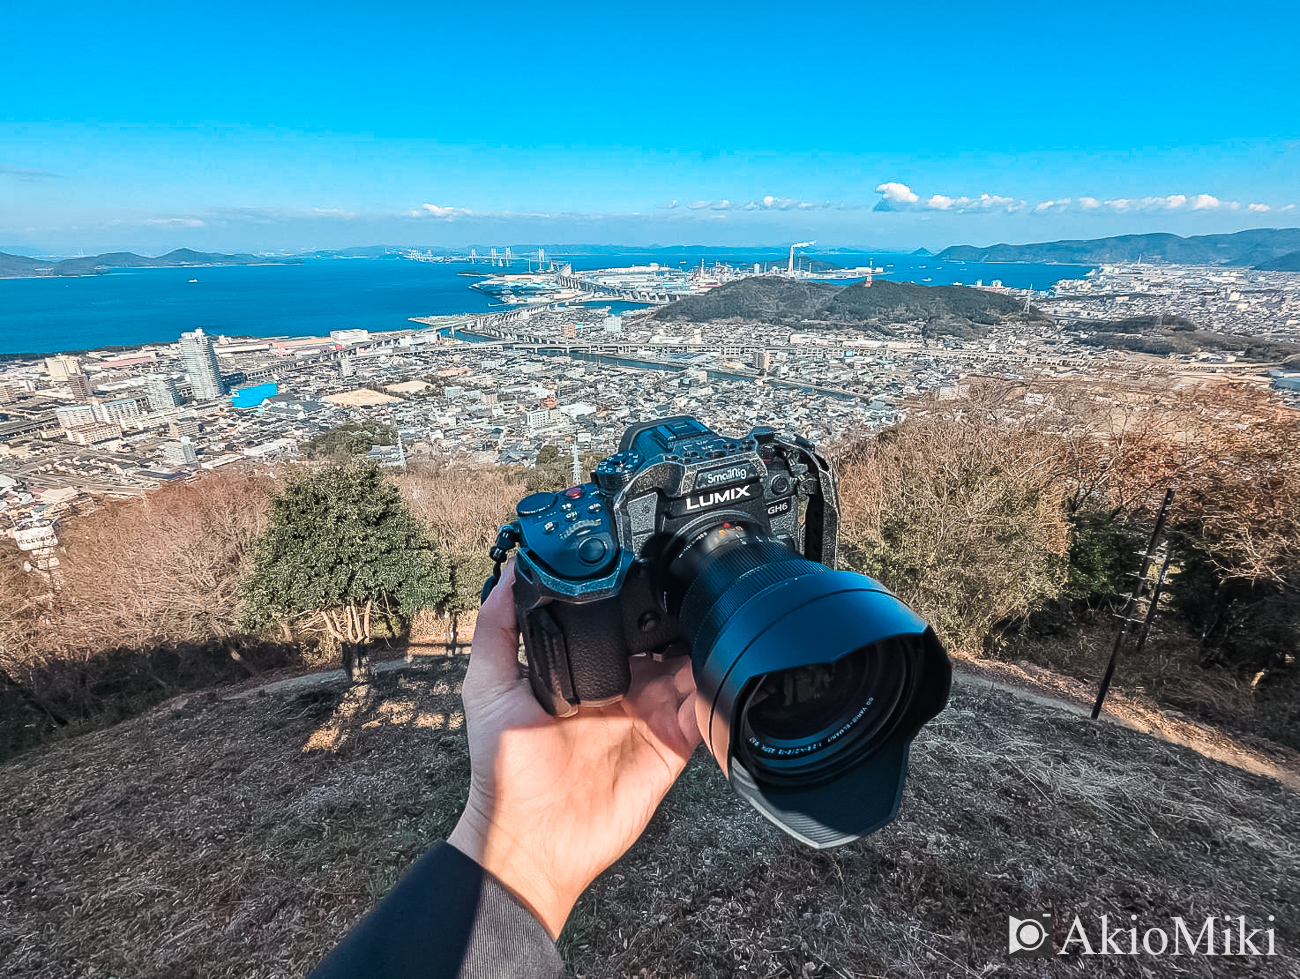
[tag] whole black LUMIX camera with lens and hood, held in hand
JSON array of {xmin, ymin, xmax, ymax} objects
[{"xmin": 484, "ymin": 416, "xmax": 952, "ymax": 848}]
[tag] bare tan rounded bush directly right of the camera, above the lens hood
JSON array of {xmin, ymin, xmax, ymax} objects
[{"xmin": 839, "ymin": 387, "xmax": 1069, "ymax": 650}]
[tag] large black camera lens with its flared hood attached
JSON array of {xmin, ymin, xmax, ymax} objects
[{"xmin": 666, "ymin": 524, "xmax": 950, "ymax": 846}]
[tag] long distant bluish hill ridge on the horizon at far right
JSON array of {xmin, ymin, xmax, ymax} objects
[{"xmin": 937, "ymin": 228, "xmax": 1300, "ymax": 265}]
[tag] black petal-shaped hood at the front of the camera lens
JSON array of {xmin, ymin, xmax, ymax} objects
[{"xmin": 692, "ymin": 562, "xmax": 952, "ymax": 848}]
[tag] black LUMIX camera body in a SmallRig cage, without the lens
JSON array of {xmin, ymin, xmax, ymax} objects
[{"xmin": 515, "ymin": 416, "xmax": 839, "ymax": 716}]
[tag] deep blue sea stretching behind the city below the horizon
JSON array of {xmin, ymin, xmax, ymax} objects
[{"xmin": 0, "ymin": 250, "xmax": 1091, "ymax": 355}]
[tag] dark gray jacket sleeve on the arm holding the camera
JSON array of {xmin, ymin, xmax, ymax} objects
[{"xmin": 311, "ymin": 844, "xmax": 564, "ymax": 979}]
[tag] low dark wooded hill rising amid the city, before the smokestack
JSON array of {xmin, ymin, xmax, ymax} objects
[{"xmin": 653, "ymin": 277, "xmax": 1041, "ymax": 335}]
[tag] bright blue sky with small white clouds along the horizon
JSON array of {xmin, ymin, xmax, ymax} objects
[{"xmin": 0, "ymin": 0, "xmax": 1300, "ymax": 254}]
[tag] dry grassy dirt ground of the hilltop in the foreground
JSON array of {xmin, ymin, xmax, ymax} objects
[{"xmin": 0, "ymin": 657, "xmax": 1300, "ymax": 979}]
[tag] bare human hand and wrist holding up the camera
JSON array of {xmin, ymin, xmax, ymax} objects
[{"xmin": 447, "ymin": 560, "xmax": 699, "ymax": 937}]
